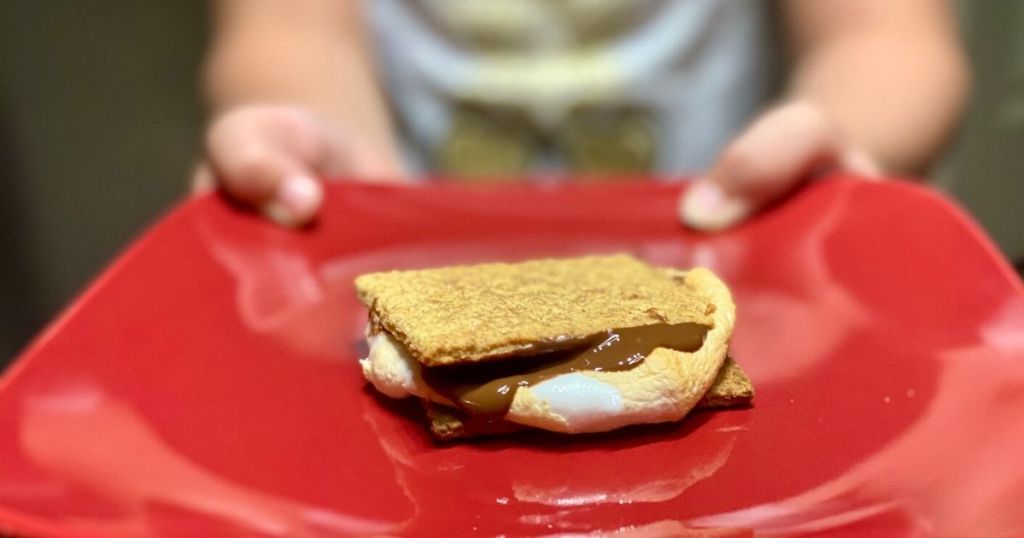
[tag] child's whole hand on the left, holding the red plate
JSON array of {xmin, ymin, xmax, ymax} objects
[{"xmin": 193, "ymin": 105, "xmax": 404, "ymax": 226}]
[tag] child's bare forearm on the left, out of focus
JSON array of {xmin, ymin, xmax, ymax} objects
[{"xmin": 205, "ymin": 0, "xmax": 397, "ymax": 158}]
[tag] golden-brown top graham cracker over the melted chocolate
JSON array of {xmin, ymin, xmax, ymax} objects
[{"xmin": 355, "ymin": 255, "xmax": 712, "ymax": 366}]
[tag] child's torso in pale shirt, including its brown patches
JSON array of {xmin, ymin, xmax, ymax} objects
[{"xmin": 371, "ymin": 0, "xmax": 774, "ymax": 173}]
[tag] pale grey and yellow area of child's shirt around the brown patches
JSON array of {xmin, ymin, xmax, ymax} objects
[{"xmin": 370, "ymin": 0, "xmax": 776, "ymax": 174}]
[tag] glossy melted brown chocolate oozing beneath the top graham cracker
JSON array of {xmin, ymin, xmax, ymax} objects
[{"xmin": 423, "ymin": 323, "xmax": 708, "ymax": 417}]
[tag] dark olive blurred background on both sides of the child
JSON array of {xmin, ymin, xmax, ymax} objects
[{"xmin": 0, "ymin": 0, "xmax": 1024, "ymax": 368}]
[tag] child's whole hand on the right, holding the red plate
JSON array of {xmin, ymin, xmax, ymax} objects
[{"xmin": 679, "ymin": 102, "xmax": 881, "ymax": 231}]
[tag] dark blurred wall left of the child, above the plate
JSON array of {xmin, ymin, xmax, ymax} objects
[{"xmin": 0, "ymin": 0, "xmax": 207, "ymax": 364}]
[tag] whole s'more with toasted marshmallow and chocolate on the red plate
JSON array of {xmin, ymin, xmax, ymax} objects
[{"xmin": 355, "ymin": 255, "xmax": 754, "ymax": 439}]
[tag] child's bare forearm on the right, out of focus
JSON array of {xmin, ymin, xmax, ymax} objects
[{"xmin": 787, "ymin": 2, "xmax": 970, "ymax": 173}]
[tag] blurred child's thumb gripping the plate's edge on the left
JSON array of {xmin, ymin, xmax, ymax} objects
[{"xmin": 207, "ymin": 108, "xmax": 324, "ymax": 225}]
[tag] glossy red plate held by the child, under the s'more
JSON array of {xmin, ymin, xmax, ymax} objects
[{"xmin": 0, "ymin": 179, "xmax": 1024, "ymax": 536}]
